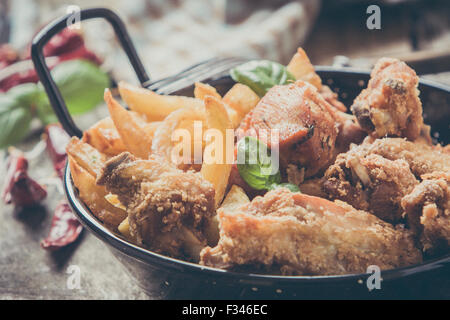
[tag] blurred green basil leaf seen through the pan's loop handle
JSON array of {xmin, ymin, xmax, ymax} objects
[{"xmin": 46, "ymin": 60, "xmax": 110, "ymax": 114}]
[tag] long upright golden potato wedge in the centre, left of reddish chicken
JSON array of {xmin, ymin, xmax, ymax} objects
[{"xmin": 201, "ymin": 96, "xmax": 233, "ymax": 207}]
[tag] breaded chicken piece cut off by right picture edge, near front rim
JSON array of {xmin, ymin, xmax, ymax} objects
[{"xmin": 401, "ymin": 171, "xmax": 450, "ymax": 253}]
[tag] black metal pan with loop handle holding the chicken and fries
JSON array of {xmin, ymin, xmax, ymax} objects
[{"xmin": 32, "ymin": 8, "xmax": 450, "ymax": 299}]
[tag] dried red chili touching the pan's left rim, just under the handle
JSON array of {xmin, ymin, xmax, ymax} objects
[{"xmin": 45, "ymin": 124, "xmax": 70, "ymax": 179}]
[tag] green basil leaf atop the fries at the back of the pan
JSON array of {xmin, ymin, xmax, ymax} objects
[{"xmin": 230, "ymin": 60, "xmax": 295, "ymax": 97}]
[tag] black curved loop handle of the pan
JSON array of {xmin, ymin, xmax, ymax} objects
[{"xmin": 31, "ymin": 8, "xmax": 150, "ymax": 138}]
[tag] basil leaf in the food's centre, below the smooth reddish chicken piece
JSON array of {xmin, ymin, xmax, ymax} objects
[{"xmin": 237, "ymin": 137, "xmax": 281, "ymax": 190}]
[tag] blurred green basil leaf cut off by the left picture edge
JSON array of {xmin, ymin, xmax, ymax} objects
[{"xmin": 0, "ymin": 94, "xmax": 33, "ymax": 148}]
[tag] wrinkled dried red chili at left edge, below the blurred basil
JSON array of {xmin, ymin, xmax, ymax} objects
[{"xmin": 2, "ymin": 150, "xmax": 47, "ymax": 207}]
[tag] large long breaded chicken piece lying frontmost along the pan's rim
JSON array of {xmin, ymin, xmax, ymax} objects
[{"xmin": 200, "ymin": 188, "xmax": 422, "ymax": 275}]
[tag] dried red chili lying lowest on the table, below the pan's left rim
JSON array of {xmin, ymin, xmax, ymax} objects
[{"xmin": 41, "ymin": 200, "xmax": 83, "ymax": 250}]
